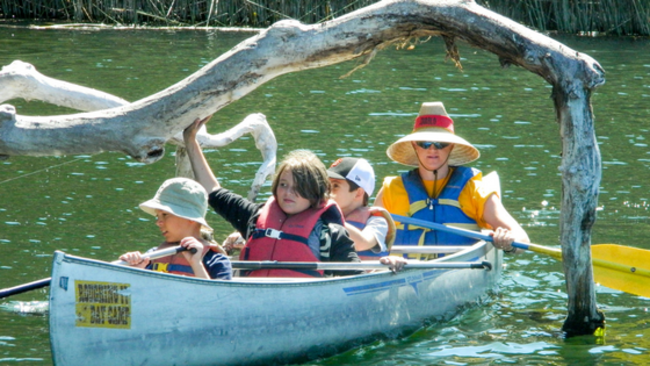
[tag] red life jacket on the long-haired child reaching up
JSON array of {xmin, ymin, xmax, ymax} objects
[{"xmin": 239, "ymin": 197, "xmax": 343, "ymax": 277}]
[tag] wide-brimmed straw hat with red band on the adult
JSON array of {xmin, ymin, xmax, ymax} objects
[{"xmin": 386, "ymin": 102, "xmax": 481, "ymax": 166}]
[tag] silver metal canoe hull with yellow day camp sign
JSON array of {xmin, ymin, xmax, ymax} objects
[{"xmin": 50, "ymin": 243, "xmax": 502, "ymax": 366}]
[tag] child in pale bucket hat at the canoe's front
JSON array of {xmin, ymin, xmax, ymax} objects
[{"xmin": 120, "ymin": 178, "xmax": 232, "ymax": 280}]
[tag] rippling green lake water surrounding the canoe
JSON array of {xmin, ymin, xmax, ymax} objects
[{"xmin": 0, "ymin": 24, "xmax": 650, "ymax": 366}]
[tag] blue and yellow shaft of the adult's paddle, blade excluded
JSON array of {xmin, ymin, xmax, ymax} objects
[{"xmin": 391, "ymin": 215, "xmax": 650, "ymax": 277}]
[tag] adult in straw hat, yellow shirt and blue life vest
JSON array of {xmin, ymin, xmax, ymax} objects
[{"xmin": 375, "ymin": 102, "xmax": 529, "ymax": 258}]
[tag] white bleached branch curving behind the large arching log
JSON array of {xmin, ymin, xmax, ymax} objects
[{"xmin": 0, "ymin": 60, "xmax": 278, "ymax": 201}]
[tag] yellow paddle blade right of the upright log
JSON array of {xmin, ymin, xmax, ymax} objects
[{"xmin": 591, "ymin": 244, "xmax": 650, "ymax": 297}]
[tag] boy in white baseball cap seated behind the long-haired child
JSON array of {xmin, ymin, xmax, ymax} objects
[{"xmin": 327, "ymin": 158, "xmax": 395, "ymax": 260}]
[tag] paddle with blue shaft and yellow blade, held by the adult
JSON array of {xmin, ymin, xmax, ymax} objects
[{"xmin": 391, "ymin": 215, "xmax": 650, "ymax": 297}]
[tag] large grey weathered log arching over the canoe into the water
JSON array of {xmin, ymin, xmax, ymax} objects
[{"xmin": 0, "ymin": 0, "xmax": 605, "ymax": 335}]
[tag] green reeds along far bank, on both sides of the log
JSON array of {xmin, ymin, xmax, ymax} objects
[{"xmin": 0, "ymin": 0, "xmax": 650, "ymax": 35}]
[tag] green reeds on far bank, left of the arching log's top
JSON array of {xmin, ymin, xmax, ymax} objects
[{"xmin": 0, "ymin": 0, "xmax": 377, "ymax": 27}]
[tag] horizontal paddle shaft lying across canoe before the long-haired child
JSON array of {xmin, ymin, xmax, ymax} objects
[{"xmin": 230, "ymin": 261, "xmax": 492, "ymax": 271}]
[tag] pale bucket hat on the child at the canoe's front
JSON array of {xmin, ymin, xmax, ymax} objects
[{"xmin": 140, "ymin": 178, "xmax": 212, "ymax": 231}]
